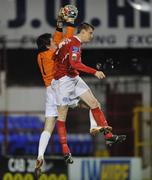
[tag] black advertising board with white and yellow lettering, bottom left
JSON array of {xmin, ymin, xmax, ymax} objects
[{"xmin": 0, "ymin": 157, "xmax": 68, "ymax": 180}]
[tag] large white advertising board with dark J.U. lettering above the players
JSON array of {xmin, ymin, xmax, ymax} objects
[{"xmin": 0, "ymin": 0, "xmax": 152, "ymax": 48}]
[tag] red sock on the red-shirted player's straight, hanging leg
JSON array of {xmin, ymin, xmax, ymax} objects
[{"xmin": 57, "ymin": 120, "xmax": 70, "ymax": 154}]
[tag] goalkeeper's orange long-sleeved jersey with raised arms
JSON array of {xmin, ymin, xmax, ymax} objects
[{"xmin": 37, "ymin": 26, "xmax": 74, "ymax": 87}]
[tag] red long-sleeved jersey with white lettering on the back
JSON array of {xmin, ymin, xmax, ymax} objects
[{"xmin": 54, "ymin": 36, "xmax": 96, "ymax": 79}]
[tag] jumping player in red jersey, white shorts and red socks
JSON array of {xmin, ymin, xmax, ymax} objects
[{"xmin": 53, "ymin": 23, "xmax": 126, "ymax": 152}]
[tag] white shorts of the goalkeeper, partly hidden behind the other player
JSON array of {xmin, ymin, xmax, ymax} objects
[{"xmin": 45, "ymin": 86, "xmax": 58, "ymax": 117}]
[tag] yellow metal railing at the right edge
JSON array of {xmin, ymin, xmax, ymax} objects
[{"xmin": 133, "ymin": 107, "xmax": 152, "ymax": 179}]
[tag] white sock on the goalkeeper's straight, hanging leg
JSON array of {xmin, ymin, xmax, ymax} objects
[{"xmin": 38, "ymin": 131, "xmax": 51, "ymax": 159}]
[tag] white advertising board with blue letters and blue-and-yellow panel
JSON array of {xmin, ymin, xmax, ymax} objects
[{"xmin": 69, "ymin": 158, "xmax": 142, "ymax": 180}]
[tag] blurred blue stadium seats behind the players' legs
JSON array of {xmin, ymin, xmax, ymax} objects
[{"xmin": 0, "ymin": 112, "xmax": 94, "ymax": 156}]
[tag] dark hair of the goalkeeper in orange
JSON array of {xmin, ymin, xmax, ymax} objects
[{"xmin": 36, "ymin": 33, "xmax": 52, "ymax": 51}]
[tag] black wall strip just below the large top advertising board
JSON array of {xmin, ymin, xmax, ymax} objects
[{"xmin": 0, "ymin": 49, "xmax": 152, "ymax": 86}]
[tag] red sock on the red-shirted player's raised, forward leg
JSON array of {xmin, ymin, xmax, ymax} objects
[{"xmin": 91, "ymin": 107, "xmax": 112, "ymax": 138}]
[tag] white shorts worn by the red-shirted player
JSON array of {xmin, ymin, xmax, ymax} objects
[{"xmin": 52, "ymin": 76, "xmax": 90, "ymax": 105}]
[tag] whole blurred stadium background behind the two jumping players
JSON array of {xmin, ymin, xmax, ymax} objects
[{"xmin": 0, "ymin": 0, "xmax": 152, "ymax": 180}]
